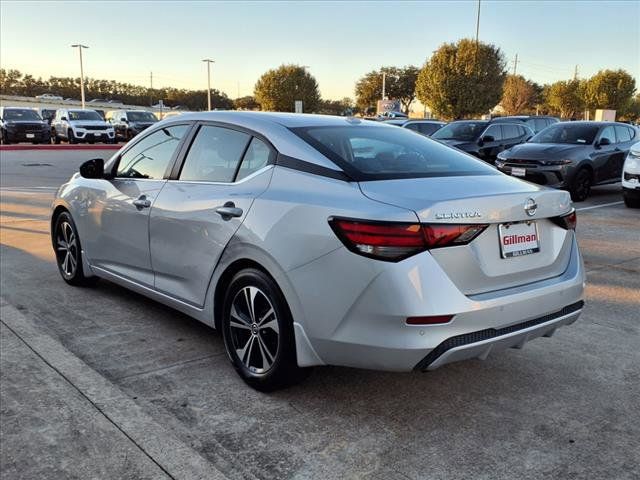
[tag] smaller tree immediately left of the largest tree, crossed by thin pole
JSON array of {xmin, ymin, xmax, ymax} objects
[{"xmin": 356, "ymin": 65, "xmax": 419, "ymax": 113}]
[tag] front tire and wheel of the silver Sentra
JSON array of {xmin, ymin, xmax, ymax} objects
[{"xmin": 51, "ymin": 212, "xmax": 98, "ymax": 287}]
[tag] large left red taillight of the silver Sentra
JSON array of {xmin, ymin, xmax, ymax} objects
[{"xmin": 329, "ymin": 218, "xmax": 487, "ymax": 262}]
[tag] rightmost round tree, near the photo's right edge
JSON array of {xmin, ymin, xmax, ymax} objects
[{"xmin": 584, "ymin": 69, "xmax": 636, "ymax": 112}]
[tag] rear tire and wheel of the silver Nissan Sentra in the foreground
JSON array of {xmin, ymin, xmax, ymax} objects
[{"xmin": 221, "ymin": 268, "xmax": 311, "ymax": 392}]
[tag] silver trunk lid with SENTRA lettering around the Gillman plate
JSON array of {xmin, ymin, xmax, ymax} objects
[{"xmin": 360, "ymin": 175, "xmax": 573, "ymax": 295}]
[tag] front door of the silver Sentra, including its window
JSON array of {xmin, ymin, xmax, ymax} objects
[{"xmin": 83, "ymin": 124, "xmax": 190, "ymax": 287}]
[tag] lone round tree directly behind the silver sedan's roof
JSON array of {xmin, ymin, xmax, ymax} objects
[{"xmin": 254, "ymin": 65, "xmax": 320, "ymax": 112}]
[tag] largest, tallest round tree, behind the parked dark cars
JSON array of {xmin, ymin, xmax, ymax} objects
[{"xmin": 416, "ymin": 39, "xmax": 506, "ymax": 119}]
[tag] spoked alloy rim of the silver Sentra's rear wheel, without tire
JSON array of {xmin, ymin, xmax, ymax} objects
[{"xmin": 229, "ymin": 286, "xmax": 280, "ymax": 374}]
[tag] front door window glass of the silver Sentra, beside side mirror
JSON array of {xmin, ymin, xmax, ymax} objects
[{"xmin": 116, "ymin": 125, "xmax": 189, "ymax": 180}]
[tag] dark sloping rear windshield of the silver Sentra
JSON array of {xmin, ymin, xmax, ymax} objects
[{"xmin": 291, "ymin": 125, "xmax": 499, "ymax": 181}]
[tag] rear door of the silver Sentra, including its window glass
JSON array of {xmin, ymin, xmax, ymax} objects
[{"xmin": 150, "ymin": 124, "xmax": 275, "ymax": 306}]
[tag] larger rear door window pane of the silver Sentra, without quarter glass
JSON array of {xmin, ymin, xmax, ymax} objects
[{"xmin": 180, "ymin": 125, "xmax": 251, "ymax": 183}]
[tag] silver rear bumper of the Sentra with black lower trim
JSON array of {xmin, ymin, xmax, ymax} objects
[{"xmin": 289, "ymin": 232, "xmax": 585, "ymax": 371}]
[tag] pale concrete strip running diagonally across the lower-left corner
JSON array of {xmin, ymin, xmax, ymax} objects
[{"xmin": 0, "ymin": 298, "xmax": 228, "ymax": 480}]
